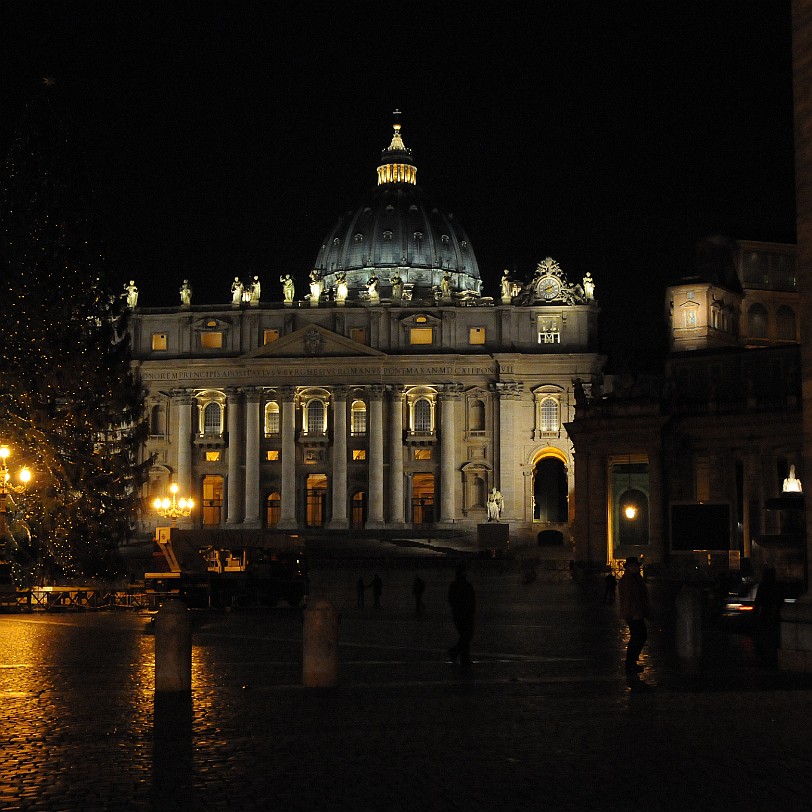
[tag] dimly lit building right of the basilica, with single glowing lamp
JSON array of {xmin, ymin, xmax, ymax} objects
[{"xmin": 567, "ymin": 236, "xmax": 806, "ymax": 584}]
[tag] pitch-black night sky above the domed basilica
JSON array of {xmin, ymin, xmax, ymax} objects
[{"xmin": 0, "ymin": 0, "xmax": 795, "ymax": 370}]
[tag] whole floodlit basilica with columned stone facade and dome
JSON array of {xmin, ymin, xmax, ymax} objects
[{"xmin": 130, "ymin": 124, "xmax": 604, "ymax": 547}]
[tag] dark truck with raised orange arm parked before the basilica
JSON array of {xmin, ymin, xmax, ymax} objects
[{"xmin": 144, "ymin": 527, "xmax": 307, "ymax": 608}]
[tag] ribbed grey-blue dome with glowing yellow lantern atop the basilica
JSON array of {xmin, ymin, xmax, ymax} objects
[{"xmin": 315, "ymin": 115, "xmax": 481, "ymax": 301}]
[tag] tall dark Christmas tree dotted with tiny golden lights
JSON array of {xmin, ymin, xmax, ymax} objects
[{"xmin": 0, "ymin": 84, "xmax": 147, "ymax": 580}]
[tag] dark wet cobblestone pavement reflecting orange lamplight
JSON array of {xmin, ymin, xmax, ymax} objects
[{"xmin": 0, "ymin": 562, "xmax": 812, "ymax": 812}]
